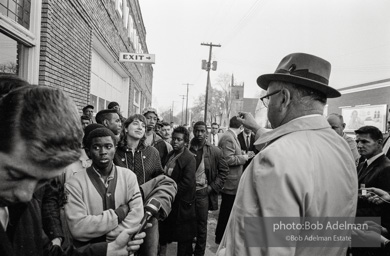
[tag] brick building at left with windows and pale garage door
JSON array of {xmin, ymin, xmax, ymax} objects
[{"xmin": 0, "ymin": 0, "xmax": 153, "ymax": 116}]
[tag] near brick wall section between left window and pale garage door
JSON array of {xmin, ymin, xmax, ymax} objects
[{"xmin": 39, "ymin": 0, "xmax": 92, "ymax": 109}]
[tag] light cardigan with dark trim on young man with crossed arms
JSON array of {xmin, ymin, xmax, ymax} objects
[{"xmin": 65, "ymin": 166, "xmax": 144, "ymax": 242}]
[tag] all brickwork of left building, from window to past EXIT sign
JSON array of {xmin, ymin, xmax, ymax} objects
[{"xmin": 39, "ymin": 0, "xmax": 153, "ymax": 113}]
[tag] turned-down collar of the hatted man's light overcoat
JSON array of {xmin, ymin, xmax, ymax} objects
[{"xmin": 254, "ymin": 116, "xmax": 331, "ymax": 145}]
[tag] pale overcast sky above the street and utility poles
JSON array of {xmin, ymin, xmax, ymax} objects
[{"xmin": 139, "ymin": 0, "xmax": 390, "ymax": 114}]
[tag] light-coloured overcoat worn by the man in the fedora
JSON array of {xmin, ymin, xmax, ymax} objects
[{"xmin": 218, "ymin": 115, "xmax": 358, "ymax": 256}]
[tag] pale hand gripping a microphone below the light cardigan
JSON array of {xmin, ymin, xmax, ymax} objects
[{"xmin": 107, "ymin": 225, "xmax": 146, "ymax": 256}]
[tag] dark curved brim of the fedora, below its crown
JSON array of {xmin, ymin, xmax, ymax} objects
[{"xmin": 257, "ymin": 74, "xmax": 341, "ymax": 98}]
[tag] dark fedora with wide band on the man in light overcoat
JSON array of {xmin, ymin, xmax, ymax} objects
[{"xmin": 257, "ymin": 53, "xmax": 341, "ymax": 98}]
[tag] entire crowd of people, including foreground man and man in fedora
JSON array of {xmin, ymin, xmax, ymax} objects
[{"xmin": 0, "ymin": 53, "xmax": 390, "ymax": 256}]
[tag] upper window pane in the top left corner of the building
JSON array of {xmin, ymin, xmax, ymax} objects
[{"xmin": 0, "ymin": 0, "xmax": 31, "ymax": 29}]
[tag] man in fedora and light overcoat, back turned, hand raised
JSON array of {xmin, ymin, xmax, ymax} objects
[{"xmin": 218, "ymin": 53, "xmax": 358, "ymax": 256}]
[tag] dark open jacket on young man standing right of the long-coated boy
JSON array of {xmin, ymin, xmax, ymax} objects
[{"xmin": 189, "ymin": 141, "xmax": 229, "ymax": 211}]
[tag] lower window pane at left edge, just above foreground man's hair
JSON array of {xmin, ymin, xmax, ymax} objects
[{"xmin": 0, "ymin": 31, "xmax": 21, "ymax": 75}]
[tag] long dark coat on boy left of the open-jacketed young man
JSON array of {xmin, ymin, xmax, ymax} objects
[{"xmin": 160, "ymin": 148, "xmax": 196, "ymax": 244}]
